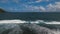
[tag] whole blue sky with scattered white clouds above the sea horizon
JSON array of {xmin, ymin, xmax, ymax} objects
[{"xmin": 0, "ymin": 0, "xmax": 60, "ymax": 12}]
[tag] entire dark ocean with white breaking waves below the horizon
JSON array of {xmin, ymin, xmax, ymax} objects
[{"xmin": 0, "ymin": 12, "xmax": 60, "ymax": 34}]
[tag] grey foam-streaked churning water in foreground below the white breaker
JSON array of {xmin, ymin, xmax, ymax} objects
[{"xmin": 0, "ymin": 23, "xmax": 54, "ymax": 34}]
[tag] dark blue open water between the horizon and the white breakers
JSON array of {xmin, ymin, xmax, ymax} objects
[{"xmin": 0, "ymin": 12, "xmax": 60, "ymax": 21}]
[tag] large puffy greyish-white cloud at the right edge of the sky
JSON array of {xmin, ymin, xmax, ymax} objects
[{"xmin": 46, "ymin": 2, "xmax": 60, "ymax": 12}]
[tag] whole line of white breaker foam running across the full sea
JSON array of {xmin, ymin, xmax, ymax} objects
[{"xmin": 0, "ymin": 19, "xmax": 60, "ymax": 24}]
